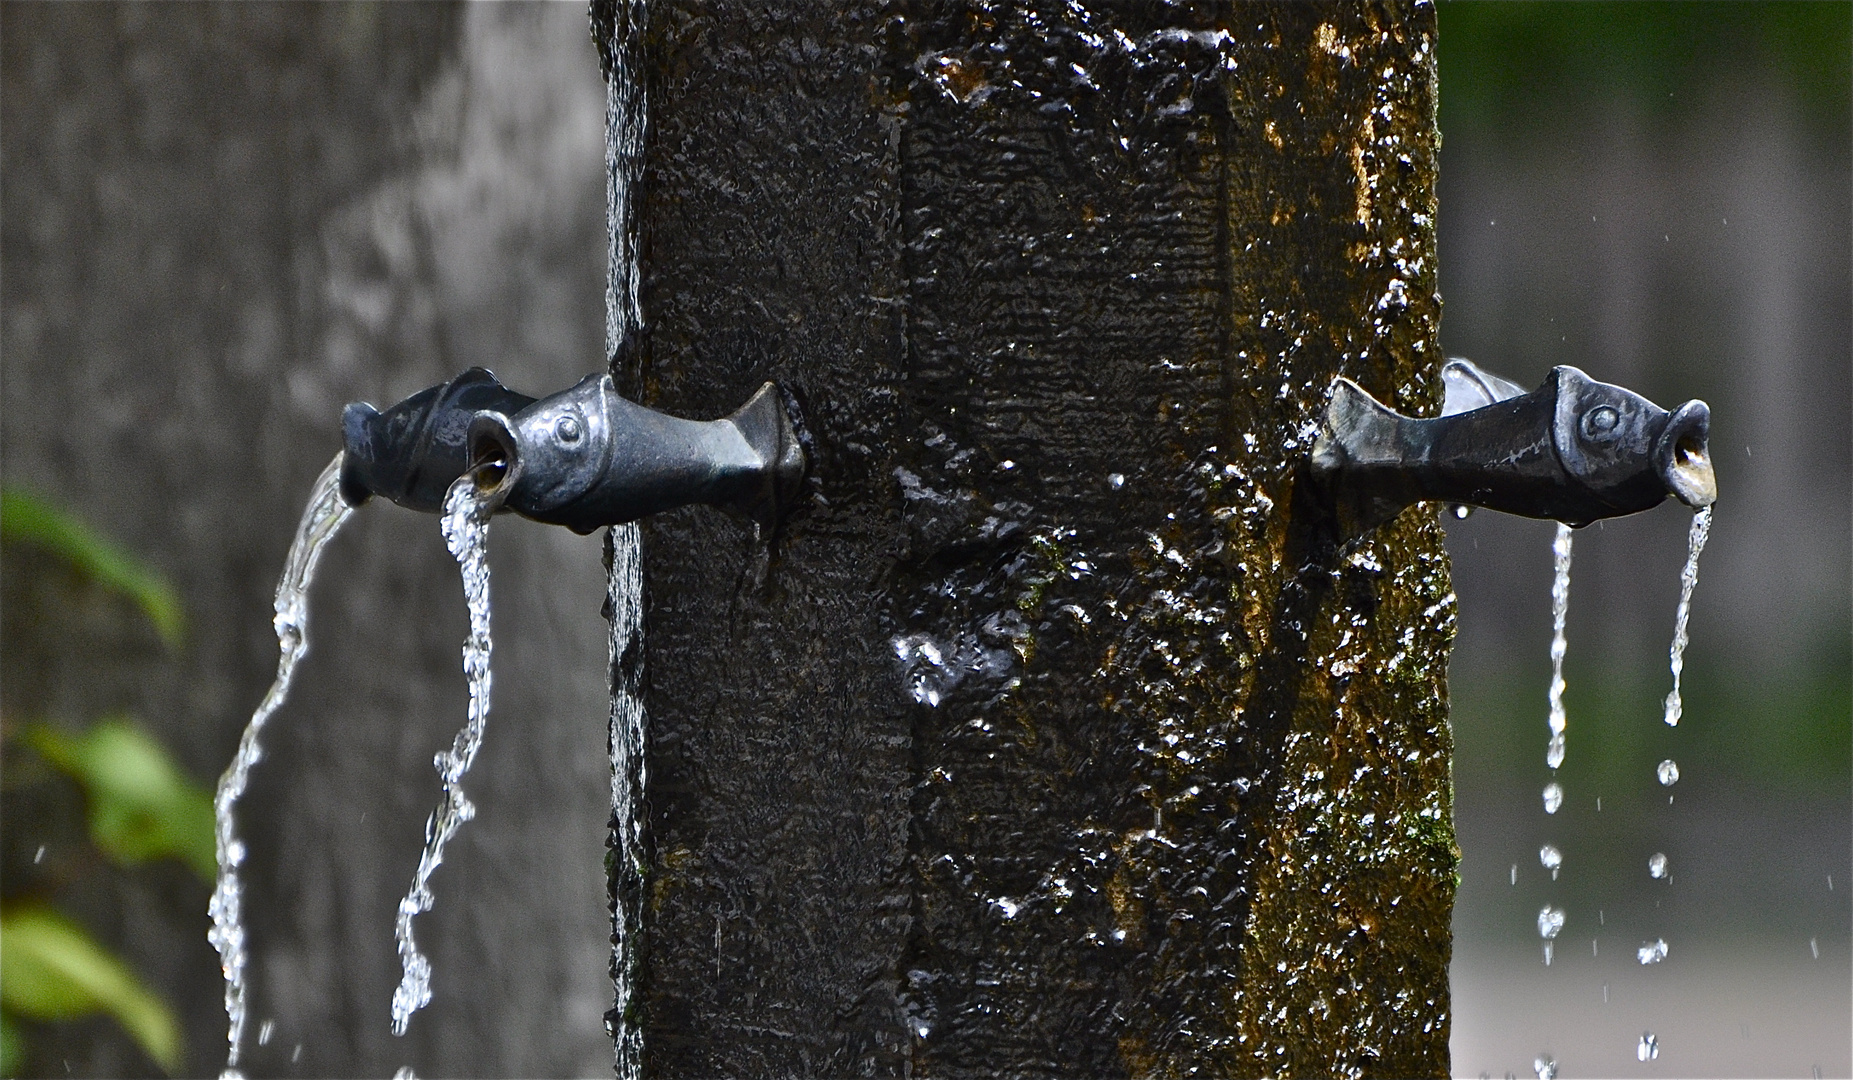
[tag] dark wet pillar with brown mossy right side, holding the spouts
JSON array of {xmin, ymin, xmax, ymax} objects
[{"xmin": 617, "ymin": 4, "xmax": 1456, "ymax": 1076}]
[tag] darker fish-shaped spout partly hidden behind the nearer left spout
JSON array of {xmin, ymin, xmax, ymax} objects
[{"xmin": 341, "ymin": 367, "xmax": 534, "ymax": 513}]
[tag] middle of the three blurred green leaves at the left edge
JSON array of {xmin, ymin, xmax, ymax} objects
[{"xmin": 26, "ymin": 717, "xmax": 219, "ymax": 882}]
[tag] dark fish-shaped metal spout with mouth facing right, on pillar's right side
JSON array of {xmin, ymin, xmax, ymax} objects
[{"xmin": 1312, "ymin": 361, "xmax": 1718, "ymax": 534}]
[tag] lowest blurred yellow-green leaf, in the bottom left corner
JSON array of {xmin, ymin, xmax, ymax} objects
[{"xmin": 0, "ymin": 908, "xmax": 180, "ymax": 1074}]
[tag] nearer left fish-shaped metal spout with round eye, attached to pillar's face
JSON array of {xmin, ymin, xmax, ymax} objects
[{"xmin": 469, "ymin": 374, "xmax": 804, "ymax": 534}]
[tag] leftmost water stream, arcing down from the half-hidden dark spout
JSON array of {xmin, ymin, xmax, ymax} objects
[{"xmin": 206, "ymin": 454, "xmax": 354, "ymax": 1076}]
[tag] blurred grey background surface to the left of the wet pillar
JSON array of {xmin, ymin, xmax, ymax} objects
[{"xmin": 0, "ymin": 4, "xmax": 611, "ymax": 1076}]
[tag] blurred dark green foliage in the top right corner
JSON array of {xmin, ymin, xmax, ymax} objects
[{"xmin": 1438, "ymin": 0, "xmax": 1853, "ymax": 137}]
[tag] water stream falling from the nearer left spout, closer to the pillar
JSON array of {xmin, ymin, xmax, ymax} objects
[{"xmin": 393, "ymin": 472, "xmax": 495, "ymax": 1036}]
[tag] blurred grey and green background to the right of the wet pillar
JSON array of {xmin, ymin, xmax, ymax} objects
[{"xmin": 1440, "ymin": 4, "xmax": 1853, "ymax": 1076}]
